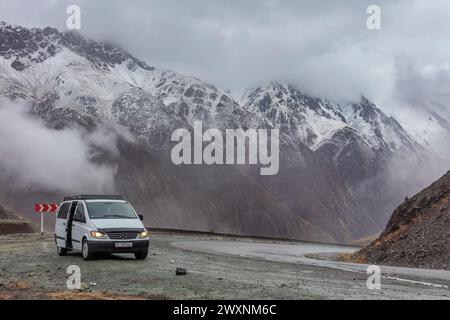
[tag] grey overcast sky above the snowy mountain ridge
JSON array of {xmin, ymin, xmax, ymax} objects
[{"xmin": 0, "ymin": 0, "xmax": 450, "ymax": 102}]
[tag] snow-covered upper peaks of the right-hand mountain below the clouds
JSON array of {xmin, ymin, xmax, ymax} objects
[{"xmin": 243, "ymin": 83, "xmax": 415, "ymax": 152}]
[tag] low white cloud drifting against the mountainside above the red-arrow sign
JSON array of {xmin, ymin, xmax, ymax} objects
[{"xmin": 0, "ymin": 99, "xmax": 118, "ymax": 193}]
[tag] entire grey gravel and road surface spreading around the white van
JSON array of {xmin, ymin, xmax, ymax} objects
[{"xmin": 0, "ymin": 234, "xmax": 450, "ymax": 299}]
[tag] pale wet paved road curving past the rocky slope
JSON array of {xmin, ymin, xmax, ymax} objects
[{"xmin": 172, "ymin": 240, "xmax": 450, "ymax": 288}]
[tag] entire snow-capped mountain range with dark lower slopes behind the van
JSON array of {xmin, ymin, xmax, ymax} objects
[{"xmin": 0, "ymin": 23, "xmax": 440, "ymax": 241}]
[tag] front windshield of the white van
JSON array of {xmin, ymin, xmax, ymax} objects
[{"xmin": 86, "ymin": 201, "xmax": 138, "ymax": 219}]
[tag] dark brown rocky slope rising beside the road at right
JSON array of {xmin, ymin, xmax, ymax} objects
[{"xmin": 357, "ymin": 171, "xmax": 450, "ymax": 270}]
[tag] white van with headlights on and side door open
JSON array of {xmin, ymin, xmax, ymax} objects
[{"xmin": 55, "ymin": 195, "xmax": 149, "ymax": 260}]
